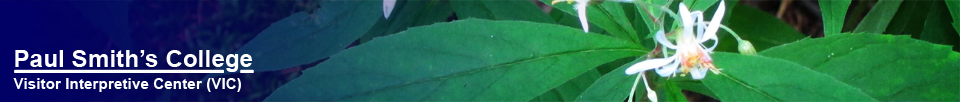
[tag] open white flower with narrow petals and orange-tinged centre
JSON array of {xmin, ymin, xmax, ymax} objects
[{"xmin": 626, "ymin": 1, "xmax": 725, "ymax": 80}]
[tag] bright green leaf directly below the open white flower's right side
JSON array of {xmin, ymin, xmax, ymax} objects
[{"xmin": 702, "ymin": 52, "xmax": 876, "ymax": 101}]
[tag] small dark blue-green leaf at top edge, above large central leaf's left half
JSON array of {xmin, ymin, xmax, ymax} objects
[{"xmin": 359, "ymin": 0, "xmax": 453, "ymax": 43}]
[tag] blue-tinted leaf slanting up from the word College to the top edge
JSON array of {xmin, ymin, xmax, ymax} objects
[{"xmin": 207, "ymin": 1, "xmax": 383, "ymax": 77}]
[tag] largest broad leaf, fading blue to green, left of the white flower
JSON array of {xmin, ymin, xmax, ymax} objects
[{"xmin": 266, "ymin": 19, "xmax": 647, "ymax": 101}]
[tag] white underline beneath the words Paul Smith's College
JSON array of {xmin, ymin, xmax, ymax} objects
[{"xmin": 13, "ymin": 69, "xmax": 227, "ymax": 73}]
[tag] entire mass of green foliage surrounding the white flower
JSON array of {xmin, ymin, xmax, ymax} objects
[{"xmin": 237, "ymin": 0, "xmax": 960, "ymax": 101}]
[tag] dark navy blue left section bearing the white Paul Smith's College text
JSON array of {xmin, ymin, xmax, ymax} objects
[{"xmin": 0, "ymin": 0, "xmax": 300, "ymax": 102}]
